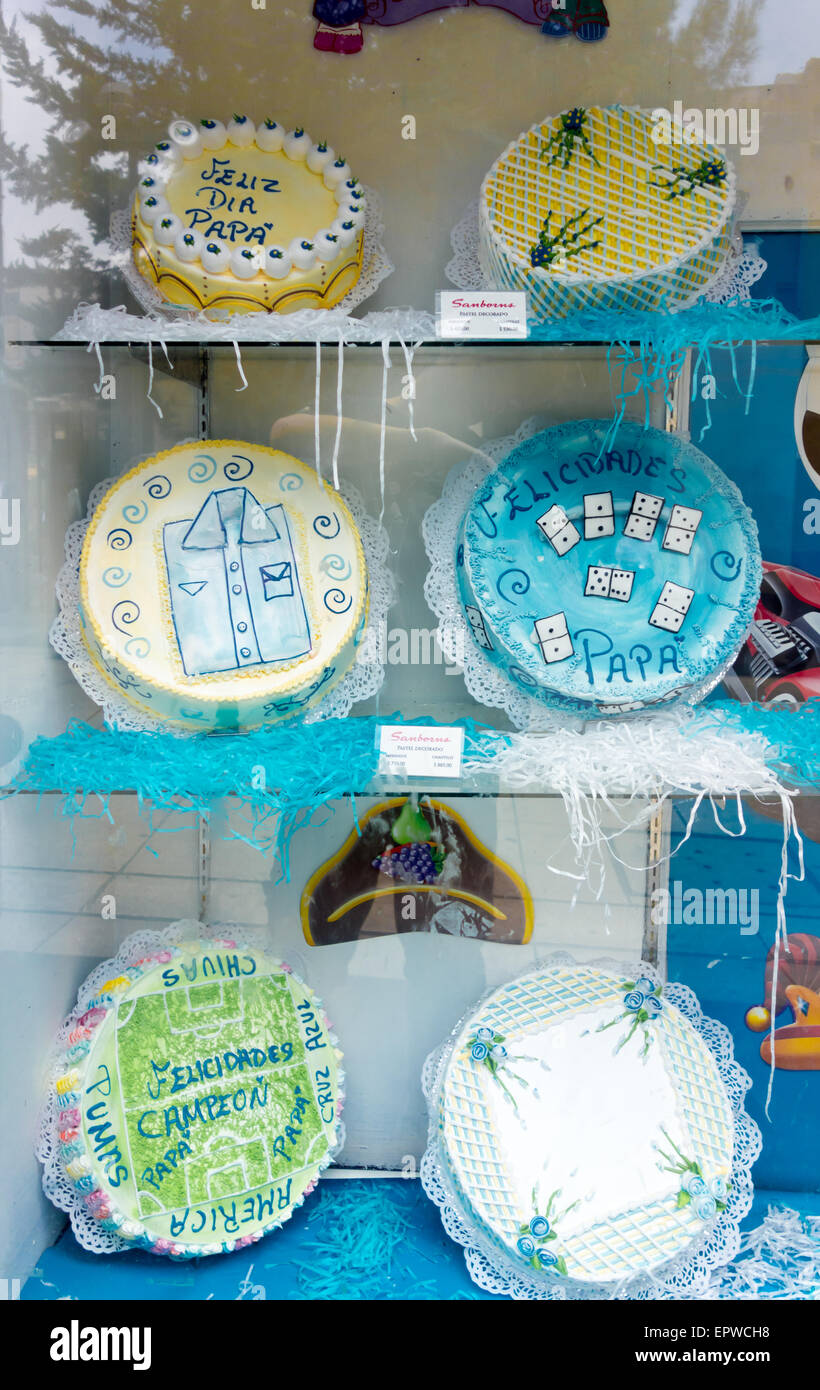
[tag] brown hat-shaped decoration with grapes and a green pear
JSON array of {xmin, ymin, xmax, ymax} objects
[{"xmin": 300, "ymin": 796, "xmax": 532, "ymax": 945}]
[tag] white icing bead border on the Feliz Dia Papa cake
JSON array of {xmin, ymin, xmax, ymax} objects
[{"xmin": 132, "ymin": 115, "xmax": 367, "ymax": 281}]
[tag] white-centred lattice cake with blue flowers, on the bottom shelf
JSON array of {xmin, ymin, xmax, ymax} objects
[{"xmin": 425, "ymin": 962, "xmax": 753, "ymax": 1286}]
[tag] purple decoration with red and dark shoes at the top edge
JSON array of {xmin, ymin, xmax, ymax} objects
[{"xmin": 313, "ymin": 0, "xmax": 609, "ymax": 53}]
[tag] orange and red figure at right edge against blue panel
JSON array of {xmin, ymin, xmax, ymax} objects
[{"xmin": 746, "ymin": 931, "xmax": 820, "ymax": 1072}]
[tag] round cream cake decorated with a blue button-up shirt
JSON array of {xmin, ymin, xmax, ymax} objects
[{"xmin": 79, "ymin": 441, "xmax": 367, "ymax": 730}]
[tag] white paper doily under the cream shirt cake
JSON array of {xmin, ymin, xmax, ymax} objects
[{"xmin": 49, "ymin": 467, "xmax": 396, "ymax": 738}]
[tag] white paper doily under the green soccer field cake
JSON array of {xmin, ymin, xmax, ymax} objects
[{"xmin": 35, "ymin": 919, "xmax": 345, "ymax": 1255}]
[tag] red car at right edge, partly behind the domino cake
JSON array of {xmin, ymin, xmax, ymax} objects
[{"xmin": 723, "ymin": 560, "xmax": 820, "ymax": 706}]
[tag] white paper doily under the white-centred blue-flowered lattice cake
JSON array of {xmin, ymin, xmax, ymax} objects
[{"xmin": 420, "ymin": 952, "xmax": 762, "ymax": 1300}]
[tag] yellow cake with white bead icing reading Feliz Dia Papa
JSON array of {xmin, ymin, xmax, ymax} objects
[{"xmin": 132, "ymin": 115, "xmax": 367, "ymax": 314}]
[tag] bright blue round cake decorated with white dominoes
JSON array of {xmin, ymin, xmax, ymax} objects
[{"xmin": 456, "ymin": 420, "xmax": 760, "ymax": 716}]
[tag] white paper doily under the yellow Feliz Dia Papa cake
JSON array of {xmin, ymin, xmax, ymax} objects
[{"xmin": 110, "ymin": 188, "xmax": 396, "ymax": 328}]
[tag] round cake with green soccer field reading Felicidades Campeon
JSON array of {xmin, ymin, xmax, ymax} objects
[{"xmin": 46, "ymin": 940, "xmax": 343, "ymax": 1258}]
